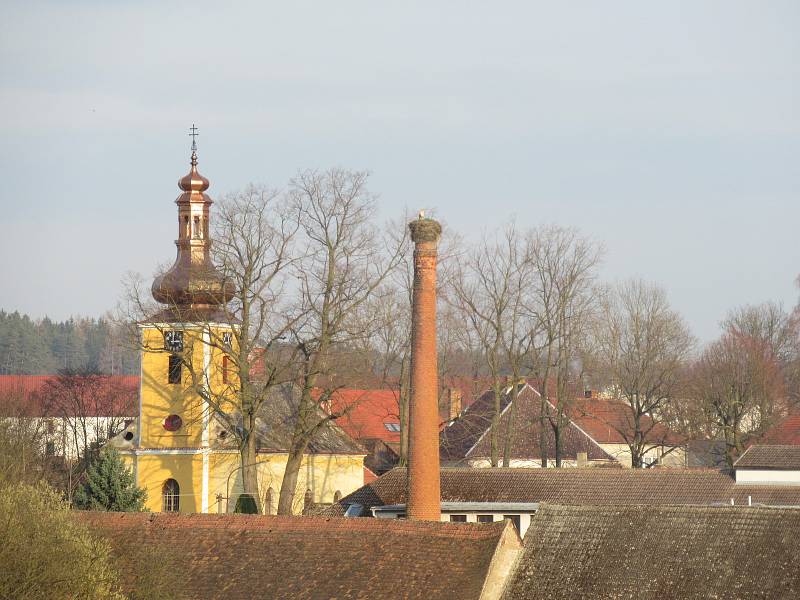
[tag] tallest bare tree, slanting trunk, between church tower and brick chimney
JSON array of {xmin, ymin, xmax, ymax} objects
[{"xmin": 278, "ymin": 169, "xmax": 402, "ymax": 514}]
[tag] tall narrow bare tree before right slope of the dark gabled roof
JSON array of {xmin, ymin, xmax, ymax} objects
[{"xmin": 527, "ymin": 226, "xmax": 602, "ymax": 467}]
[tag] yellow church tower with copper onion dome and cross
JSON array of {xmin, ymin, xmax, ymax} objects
[{"xmin": 133, "ymin": 126, "xmax": 235, "ymax": 512}]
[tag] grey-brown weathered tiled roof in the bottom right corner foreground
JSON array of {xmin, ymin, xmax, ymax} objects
[{"xmin": 504, "ymin": 505, "xmax": 800, "ymax": 600}]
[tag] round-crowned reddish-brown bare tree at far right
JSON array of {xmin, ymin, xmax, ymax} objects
[{"xmin": 691, "ymin": 332, "xmax": 785, "ymax": 466}]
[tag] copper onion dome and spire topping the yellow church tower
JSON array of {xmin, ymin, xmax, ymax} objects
[{"xmin": 152, "ymin": 131, "xmax": 236, "ymax": 320}]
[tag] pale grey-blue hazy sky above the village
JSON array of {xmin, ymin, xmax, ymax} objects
[{"xmin": 0, "ymin": 0, "xmax": 800, "ymax": 340}]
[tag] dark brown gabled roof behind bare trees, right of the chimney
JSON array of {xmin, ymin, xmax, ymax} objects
[{"xmin": 439, "ymin": 385, "xmax": 615, "ymax": 463}]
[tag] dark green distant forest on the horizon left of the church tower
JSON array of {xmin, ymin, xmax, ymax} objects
[{"xmin": 0, "ymin": 310, "xmax": 139, "ymax": 375}]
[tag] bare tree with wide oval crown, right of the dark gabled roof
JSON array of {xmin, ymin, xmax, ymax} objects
[{"xmin": 587, "ymin": 279, "xmax": 694, "ymax": 468}]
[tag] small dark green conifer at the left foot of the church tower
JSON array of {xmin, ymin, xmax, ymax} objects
[{"xmin": 75, "ymin": 448, "xmax": 147, "ymax": 512}]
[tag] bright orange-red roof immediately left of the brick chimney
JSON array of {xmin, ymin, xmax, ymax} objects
[{"xmin": 330, "ymin": 389, "xmax": 400, "ymax": 444}]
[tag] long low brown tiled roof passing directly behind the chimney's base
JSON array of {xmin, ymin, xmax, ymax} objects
[{"xmin": 319, "ymin": 468, "xmax": 800, "ymax": 516}]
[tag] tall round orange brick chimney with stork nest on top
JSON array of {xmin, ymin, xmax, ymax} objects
[{"xmin": 406, "ymin": 213, "xmax": 442, "ymax": 521}]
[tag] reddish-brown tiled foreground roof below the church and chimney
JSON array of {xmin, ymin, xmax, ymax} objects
[{"xmin": 75, "ymin": 513, "xmax": 518, "ymax": 600}]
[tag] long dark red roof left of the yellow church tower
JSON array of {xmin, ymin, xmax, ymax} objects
[{"xmin": 0, "ymin": 375, "xmax": 139, "ymax": 417}]
